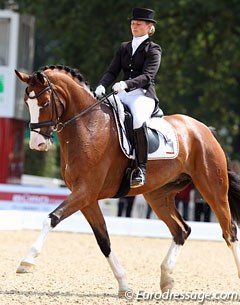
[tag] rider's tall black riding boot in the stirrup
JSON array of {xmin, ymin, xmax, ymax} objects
[{"xmin": 130, "ymin": 123, "xmax": 148, "ymax": 188}]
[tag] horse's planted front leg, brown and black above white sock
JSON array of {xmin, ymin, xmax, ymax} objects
[{"xmin": 82, "ymin": 202, "xmax": 128, "ymax": 296}]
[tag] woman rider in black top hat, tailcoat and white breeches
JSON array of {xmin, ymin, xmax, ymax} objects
[{"xmin": 95, "ymin": 8, "xmax": 161, "ymax": 188}]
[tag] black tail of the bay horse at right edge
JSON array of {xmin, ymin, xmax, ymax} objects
[{"xmin": 209, "ymin": 127, "xmax": 240, "ymax": 226}]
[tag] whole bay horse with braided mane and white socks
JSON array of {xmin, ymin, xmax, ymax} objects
[{"xmin": 15, "ymin": 66, "xmax": 240, "ymax": 295}]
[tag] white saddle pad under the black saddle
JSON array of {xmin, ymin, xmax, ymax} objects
[{"xmin": 109, "ymin": 98, "xmax": 179, "ymax": 160}]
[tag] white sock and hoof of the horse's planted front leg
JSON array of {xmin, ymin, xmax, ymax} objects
[{"xmin": 107, "ymin": 251, "xmax": 128, "ymax": 294}]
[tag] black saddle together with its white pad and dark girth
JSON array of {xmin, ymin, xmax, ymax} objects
[{"xmin": 107, "ymin": 97, "xmax": 179, "ymax": 198}]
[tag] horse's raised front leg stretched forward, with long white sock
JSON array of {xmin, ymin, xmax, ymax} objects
[{"xmin": 17, "ymin": 193, "xmax": 79, "ymax": 273}]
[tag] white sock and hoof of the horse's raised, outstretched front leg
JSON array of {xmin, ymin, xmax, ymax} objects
[{"xmin": 17, "ymin": 218, "xmax": 52, "ymax": 273}]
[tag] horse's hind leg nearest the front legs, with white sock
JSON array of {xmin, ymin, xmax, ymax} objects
[{"xmin": 144, "ymin": 190, "xmax": 191, "ymax": 292}]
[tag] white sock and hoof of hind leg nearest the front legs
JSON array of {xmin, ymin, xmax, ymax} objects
[{"xmin": 160, "ymin": 241, "xmax": 182, "ymax": 292}]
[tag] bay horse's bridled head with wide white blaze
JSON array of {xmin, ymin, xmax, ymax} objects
[{"xmin": 15, "ymin": 70, "xmax": 63, "ymax": 151}]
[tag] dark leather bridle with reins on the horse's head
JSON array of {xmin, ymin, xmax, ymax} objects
[{"xmin": 25, "ymin": 72, "xmax": 113, "ymax": 139}]
